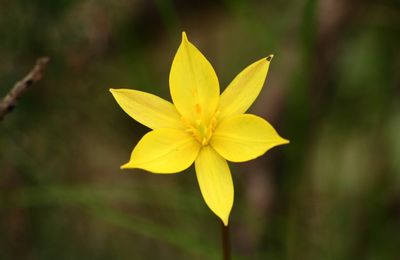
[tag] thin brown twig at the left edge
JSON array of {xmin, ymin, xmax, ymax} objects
[{"xmin": 0, "ymin": 57, "xmax": 50, "ymax": 121}]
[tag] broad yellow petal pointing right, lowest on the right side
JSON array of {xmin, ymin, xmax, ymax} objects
[{"xmin": 211, "ymin": 114, "xmax": 289, "ymax": 162}]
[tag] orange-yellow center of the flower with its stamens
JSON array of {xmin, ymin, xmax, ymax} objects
[{"xmin": 182, "ymin": 111, "xmax": 219, "ymax": 146}]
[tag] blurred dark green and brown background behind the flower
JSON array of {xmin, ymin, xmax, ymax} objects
[{"xmin": 0, "ymin": 0, "xmax": 400, "ymax": 259}]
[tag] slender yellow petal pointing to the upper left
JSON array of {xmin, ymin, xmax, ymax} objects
[{"xmin": 110, "ymin": 89, "xmax": 183, "ymax": 129}]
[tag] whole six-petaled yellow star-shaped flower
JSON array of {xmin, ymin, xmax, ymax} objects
[{"xmin": 110, "ymin": 32, "xmax": 289, "ymax": 225}]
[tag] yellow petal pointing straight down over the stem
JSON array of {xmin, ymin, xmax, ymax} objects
[{"xmin": 195, "ymin": 146, "xmax": 233, "ymax": 226}]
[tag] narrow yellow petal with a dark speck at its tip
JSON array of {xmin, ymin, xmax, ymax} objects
[{"xmin": 218, "ymin": 55, "xmax": 273, "ymax": 118}]
